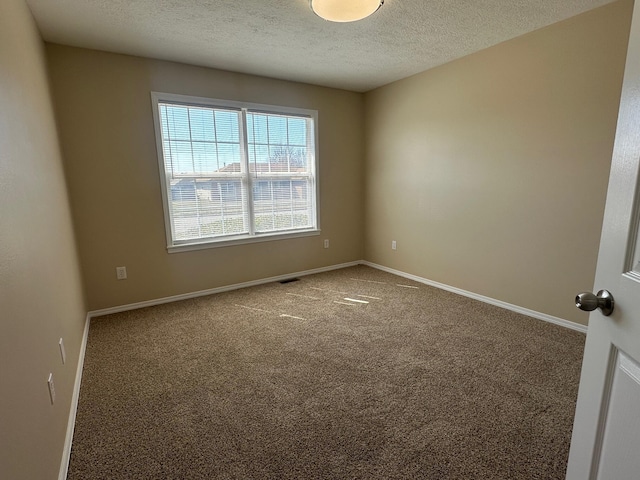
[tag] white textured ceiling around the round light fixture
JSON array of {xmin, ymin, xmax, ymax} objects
[{"xmin": 27, "ymin": 0, "xmax": 612, "ymax": 92}]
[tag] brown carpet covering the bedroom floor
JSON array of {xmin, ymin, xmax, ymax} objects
[{"xmin": 68, "ymin": 266, "xmax": 585, "ymax": 480}]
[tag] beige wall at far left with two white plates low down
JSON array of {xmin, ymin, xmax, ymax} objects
[{"xmin": 0, "ymin": 0, "xmax": 86, "ymax": 480}]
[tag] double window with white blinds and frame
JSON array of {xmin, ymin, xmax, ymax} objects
[{"xmin": 151, "ymin": 92, "xmax": 318, "ymax": 251}]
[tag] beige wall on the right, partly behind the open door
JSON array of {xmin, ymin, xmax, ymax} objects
[{"xmin": 365, "ymin": 0, "xmax": 632, "ymax": 323}]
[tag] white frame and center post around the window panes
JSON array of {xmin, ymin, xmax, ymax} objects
[{"xmin": 151, "ymin": 92, "xmax": 320, "ymax": 253}]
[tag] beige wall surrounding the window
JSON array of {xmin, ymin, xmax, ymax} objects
[{"xmin": 47, "ymin": 45, "xmax": 364, "ymax": 310}]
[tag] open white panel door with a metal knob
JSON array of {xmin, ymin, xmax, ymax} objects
[{"xmin": 567, "ymin": 1, "xmax": 640, "ymax": 480}]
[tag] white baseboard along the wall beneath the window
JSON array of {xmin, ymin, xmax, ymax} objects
[{"xmin": 89, "ymin": 261, "xmax": 362, "ymax": 318}]
